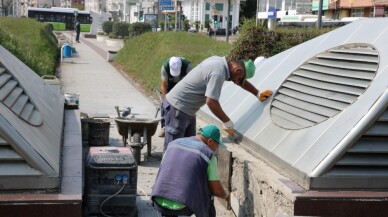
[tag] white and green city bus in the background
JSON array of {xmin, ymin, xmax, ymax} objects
[{"xmin": 27, "ymin": 7, "xmax": 93, "ymax": 32}]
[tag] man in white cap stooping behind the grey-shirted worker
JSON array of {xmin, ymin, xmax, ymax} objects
[{"xmin": 159, "ymin": 56, "xmax": 192, "ymax": 137}]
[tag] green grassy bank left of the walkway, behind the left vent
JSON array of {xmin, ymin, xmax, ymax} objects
[{"xmin": 0, "ymin": 17, "xmax": 59, "ymax": 76}]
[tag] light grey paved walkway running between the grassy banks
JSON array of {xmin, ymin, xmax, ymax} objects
[{"xmin": 58, "ymin": 32, "xmax": 234, "ymax": 217}]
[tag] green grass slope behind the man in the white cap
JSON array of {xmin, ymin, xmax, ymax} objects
[{"xmin": 115, "ymin": 32, "xmax": 232, "ymax": 91}]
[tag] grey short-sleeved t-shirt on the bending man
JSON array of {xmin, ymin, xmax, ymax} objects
[{"xmin": 166, "ymin": 56, "xmax": 230, "ymax": 116}]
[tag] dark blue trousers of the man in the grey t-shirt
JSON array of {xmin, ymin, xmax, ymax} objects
[{"xmin": 163, "ymin": 100, "xmax": 197, "ymax": 151}]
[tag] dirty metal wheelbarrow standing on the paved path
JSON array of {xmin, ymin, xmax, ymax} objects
[{"xmin": 115, "ymin": 106, "xmax": 160, "ymax": 164}]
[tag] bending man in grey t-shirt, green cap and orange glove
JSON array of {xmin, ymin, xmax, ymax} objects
[{"xmin": 164, "ymin": 56, "xmax": 272, "ymax": 149}]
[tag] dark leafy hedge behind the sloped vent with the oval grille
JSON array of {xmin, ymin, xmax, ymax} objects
[{"xmin": 228, "ymin": 21, "xmax": 335, "ymax": 59}]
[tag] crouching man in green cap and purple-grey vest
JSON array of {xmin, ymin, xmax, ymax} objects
[{"xmin": 151, "ymin": 125, "xmax": 230, "ymax": 217}]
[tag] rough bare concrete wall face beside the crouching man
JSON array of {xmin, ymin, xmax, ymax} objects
[{"xmin": 227, "ymin": 143, "xmax": 305, "ymax": 217}]
